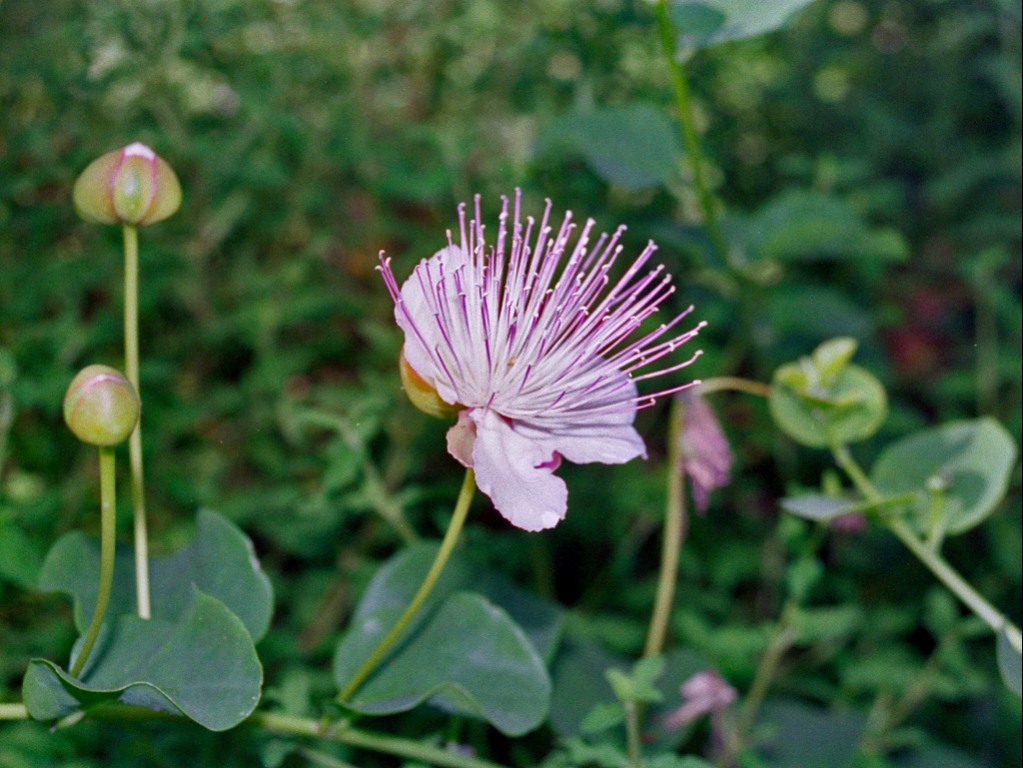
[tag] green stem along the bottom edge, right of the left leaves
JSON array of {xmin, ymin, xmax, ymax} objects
[{"xmin": 246, "ymin": 712, "xmax": 502, "ymax": 768}]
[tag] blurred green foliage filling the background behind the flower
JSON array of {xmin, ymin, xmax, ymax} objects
[{"xmin": 0, "ymin": 0, "xmax": 1023, "ymax": 768}]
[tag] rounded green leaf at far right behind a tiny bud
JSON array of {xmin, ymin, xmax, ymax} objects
[{"xmin": 871, "ymin": 418, "xmax": 1016, "ymax": 534}]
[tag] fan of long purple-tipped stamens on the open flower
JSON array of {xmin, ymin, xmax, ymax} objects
[{"xmin": 380, "ymin": 192, "xmax": 704, "ymax": 425}]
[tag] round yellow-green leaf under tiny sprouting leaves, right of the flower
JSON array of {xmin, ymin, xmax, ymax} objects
[{"xmin": 768, "ymin": 363, "xmax": 888, "ymax": 448}]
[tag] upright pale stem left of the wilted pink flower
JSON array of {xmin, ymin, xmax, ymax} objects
[{"xmin": 643, "ymin": 398, "xmax": 685, "ymax": 657}]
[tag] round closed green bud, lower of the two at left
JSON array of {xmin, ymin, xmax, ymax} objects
[{"xmin": 64, "ymin": 365, "xmax": 142, "ymax": 447}]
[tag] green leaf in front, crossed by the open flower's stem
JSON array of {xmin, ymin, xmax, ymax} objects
[{"xmin": 333, "ymin": 592, "xmax": 550, "ymax": 735}]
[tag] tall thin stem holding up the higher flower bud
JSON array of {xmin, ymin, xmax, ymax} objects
[{"xmin": 124, "ymin": 225, "xmax": 152, "ymax": 619}]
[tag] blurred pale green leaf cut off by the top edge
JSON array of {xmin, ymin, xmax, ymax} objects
[{"xmin": 671, "ymin": 0, "xmax": 812, "ymax": 49}]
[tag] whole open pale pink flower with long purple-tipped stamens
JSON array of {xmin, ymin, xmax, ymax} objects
[{"xmin": 380, "ymin": 191, "xmax": 704, "ymax": 531}]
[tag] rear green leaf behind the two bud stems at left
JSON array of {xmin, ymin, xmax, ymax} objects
[{"xmin": 39, "ymin": 509, "xmax": 273, "ymax": 640}]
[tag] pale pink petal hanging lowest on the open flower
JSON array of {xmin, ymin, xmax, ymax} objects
[{"xmin": 469, "ymin": 409, "xmax": 569, "ymax": 531}]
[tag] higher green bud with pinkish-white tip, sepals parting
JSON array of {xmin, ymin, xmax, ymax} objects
[{"xmin": 74, "ymin": 141, "xmax": 181, "ymax": 227}]
